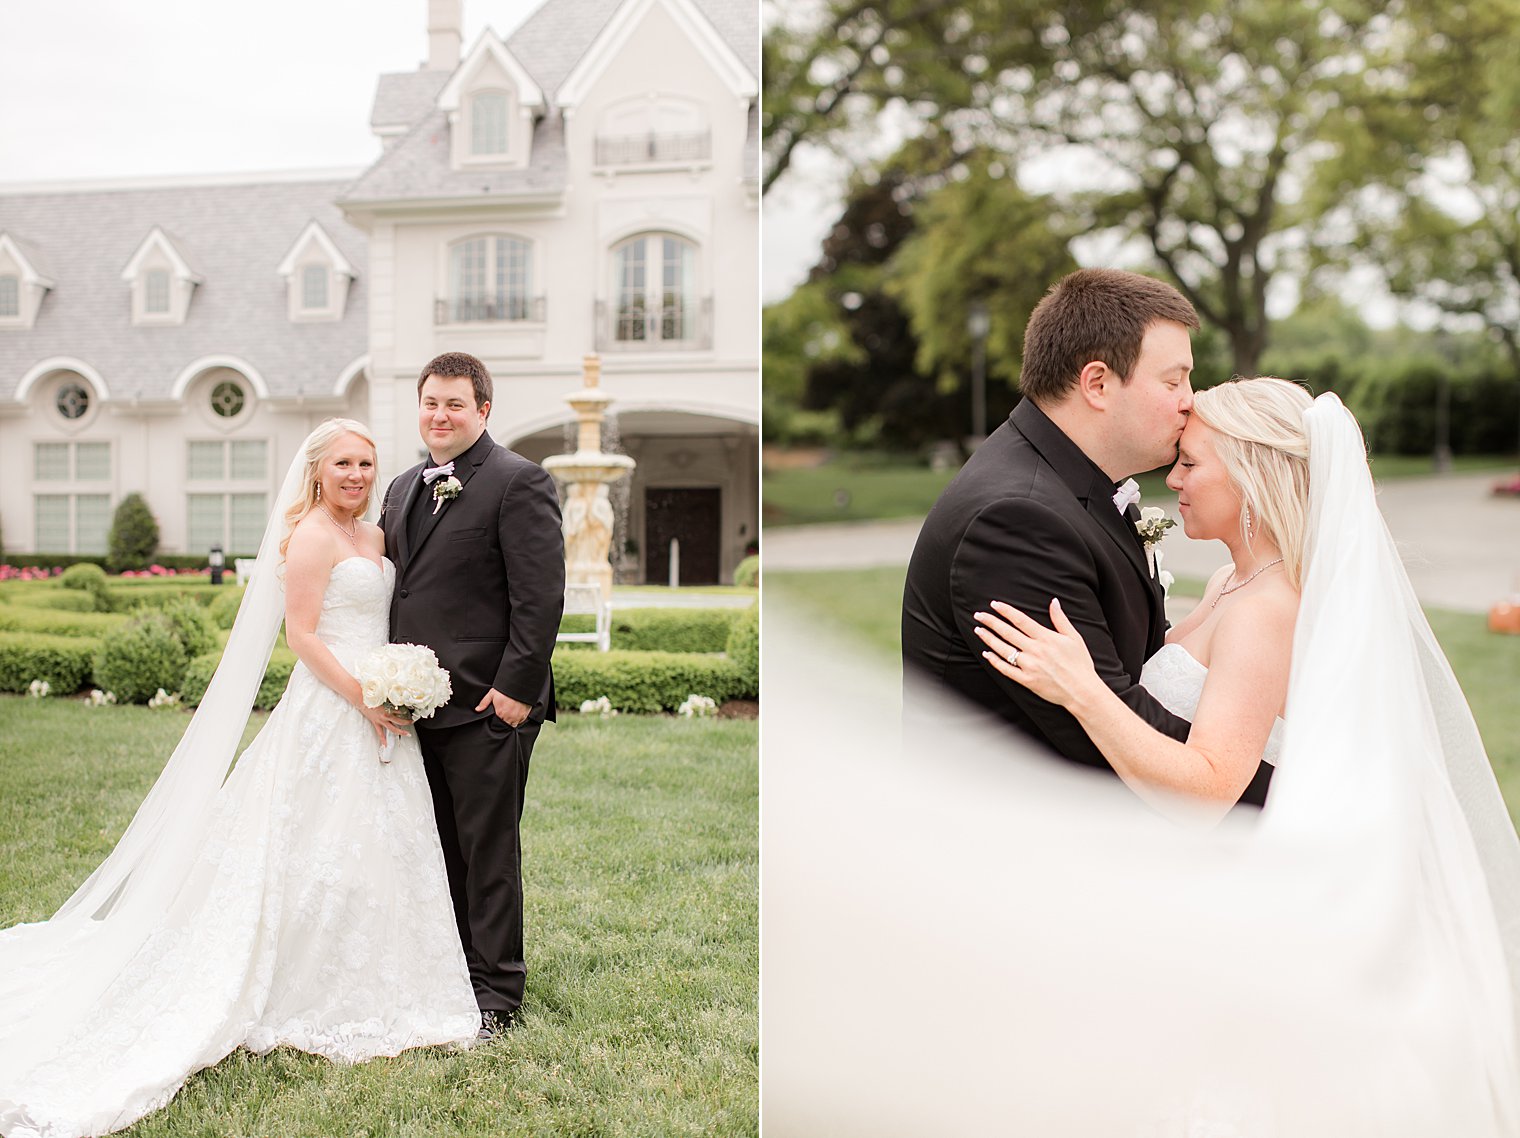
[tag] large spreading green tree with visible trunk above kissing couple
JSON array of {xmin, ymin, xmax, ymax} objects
[{"xmin": 766, "ymin": 0, "xmax": 1461, "ymax": 374}]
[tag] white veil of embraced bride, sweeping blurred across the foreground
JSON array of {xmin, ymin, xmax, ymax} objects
[{"xmin": 762, "ymin": 397, "xmax": 1520, "ymax": 1138}]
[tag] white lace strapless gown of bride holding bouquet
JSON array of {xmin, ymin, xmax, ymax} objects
[{"xmin": 0, "ymin": 556, "xmax": 479, "ymax": 1138}]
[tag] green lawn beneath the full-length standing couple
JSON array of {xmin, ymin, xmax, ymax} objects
[{"xmin": 0, "ymin": 696, "xmax": 758, "ymax": 1138}]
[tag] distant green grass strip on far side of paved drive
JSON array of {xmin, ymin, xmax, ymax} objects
[{"xmin": 760, "ymin": 453, "xmax": 1515, "ymax": 526}]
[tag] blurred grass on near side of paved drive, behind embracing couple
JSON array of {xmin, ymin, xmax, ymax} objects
[{"xmin": 765, "ymin": 567, "xmax": 1520, "ymax": 825}]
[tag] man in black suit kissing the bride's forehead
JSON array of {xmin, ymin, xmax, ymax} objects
[{"xmin": 903, "ymin": 269, "xmax": 1271, "ymax": 805}]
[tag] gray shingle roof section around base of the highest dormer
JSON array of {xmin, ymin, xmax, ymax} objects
[{"xmin": 342, "ymin": 111, "xmax": 565, "ymax": 204}]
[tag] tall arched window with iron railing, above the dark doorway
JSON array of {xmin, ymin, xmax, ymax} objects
[{"xmin": 613, "ymin": 234, "xmax": 699, "ymax": 345}]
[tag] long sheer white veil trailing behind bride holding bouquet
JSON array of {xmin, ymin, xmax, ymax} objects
[{"xmin": 0, "ymin": 431, "xmax": 307, "ymax": 1075}]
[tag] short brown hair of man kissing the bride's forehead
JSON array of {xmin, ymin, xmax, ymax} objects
[{"xmin": 1018, "ymin": 269, "xmax": 1198, "ymax": 406}]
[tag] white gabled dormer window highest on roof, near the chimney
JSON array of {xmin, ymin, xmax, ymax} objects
[{"xmin": 436, "ymin": 29, "xmax": 544, "ymax": 170}]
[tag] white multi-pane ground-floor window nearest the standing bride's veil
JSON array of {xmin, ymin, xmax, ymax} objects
[{"xmin": 185, "ymin": 439, "xmax": 269, "ymax": 553}]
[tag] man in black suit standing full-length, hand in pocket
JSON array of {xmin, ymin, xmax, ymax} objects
[{"xmin": 380, "ymin": 351, "xmax": 565, "ymax": 1038}]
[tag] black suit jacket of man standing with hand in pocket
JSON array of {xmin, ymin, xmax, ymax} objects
[{"xmin": 380, "ymin": 435, "xmax": 565, "ymax": 728}]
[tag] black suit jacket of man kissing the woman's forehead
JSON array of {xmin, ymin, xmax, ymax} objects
[{"xmin": 903, "ymin": 400, "xmax": 1271, "ymax": 804}]
